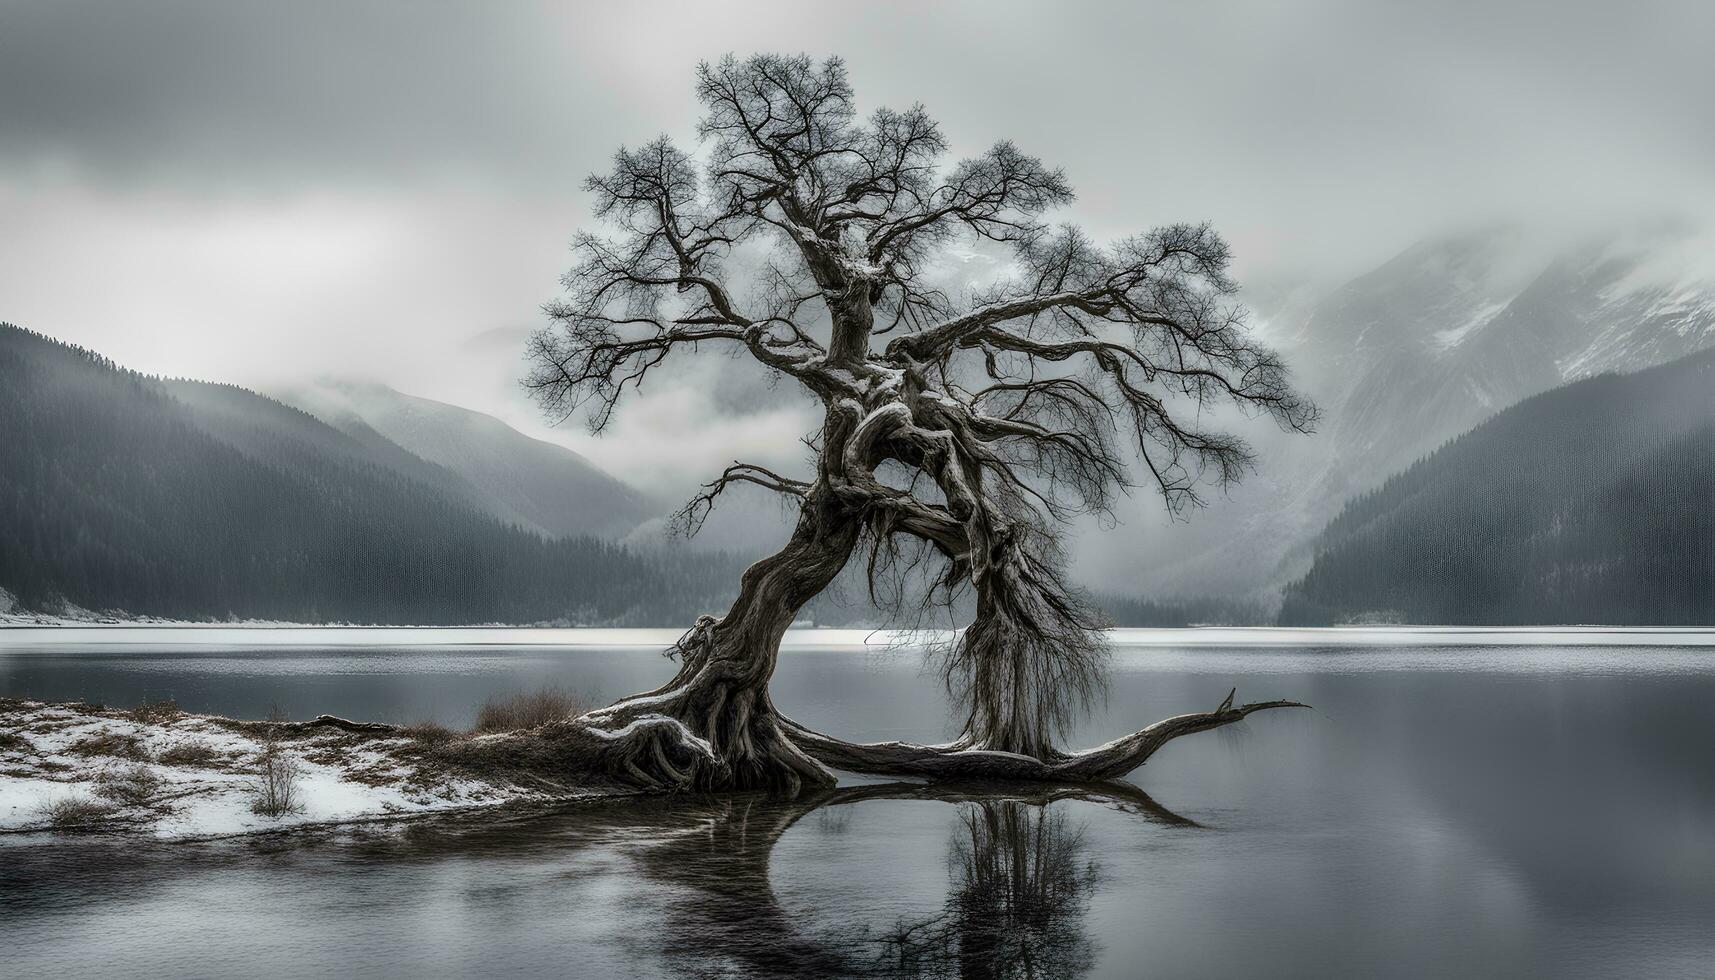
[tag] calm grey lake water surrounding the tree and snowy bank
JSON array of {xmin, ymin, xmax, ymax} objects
[{"xmin": 0, "ymin": 640, "xmax": 1715, "ymax": 978}]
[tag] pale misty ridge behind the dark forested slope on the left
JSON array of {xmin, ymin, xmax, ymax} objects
[{"xmin": 280, "ymin": 381, "xmax": 662, "ymax": 539}]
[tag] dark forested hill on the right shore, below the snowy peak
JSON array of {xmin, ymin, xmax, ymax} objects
[{"xmin": 1281, "ymin": 350, "xmax": 1715, "ymax": 625}]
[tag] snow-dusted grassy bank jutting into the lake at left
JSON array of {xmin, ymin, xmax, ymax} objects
[{"xmin": 0, "ymin": 700, "xmax": 603, "ymax": 839}]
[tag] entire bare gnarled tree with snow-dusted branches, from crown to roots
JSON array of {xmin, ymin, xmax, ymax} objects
[{"xmin": 527, "ymin": 55, "xmax": 1315, "ymax": 791}]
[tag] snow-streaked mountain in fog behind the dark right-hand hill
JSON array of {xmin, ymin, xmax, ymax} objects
[{"xmin": 1298, "ymin": 227, "xmax": 1715, "ymax": 494}]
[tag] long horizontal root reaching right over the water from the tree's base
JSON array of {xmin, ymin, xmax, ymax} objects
[{"xmin": 780, "ymin": 688, "xmax": 1309, "ymax": 781}]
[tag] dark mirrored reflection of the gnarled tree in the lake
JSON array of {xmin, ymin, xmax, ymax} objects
[{"xmin": 624, "ymin": 783, "xmax": 1195, "ymax": 978}]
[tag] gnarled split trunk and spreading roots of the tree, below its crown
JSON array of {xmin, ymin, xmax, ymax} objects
[{"xmin": 541, "ymin": 369, "xmax": 1297, "ymax": 793}]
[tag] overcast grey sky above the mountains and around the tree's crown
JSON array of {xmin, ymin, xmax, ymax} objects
[{"xmin": 0, "ymin": 0, "xmax": 1715, "ymax": 494}]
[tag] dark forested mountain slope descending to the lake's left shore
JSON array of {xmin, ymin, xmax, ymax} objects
[{"xmin": 0, "ymin": 324, "xmax": 741, "ymax": 626}]
